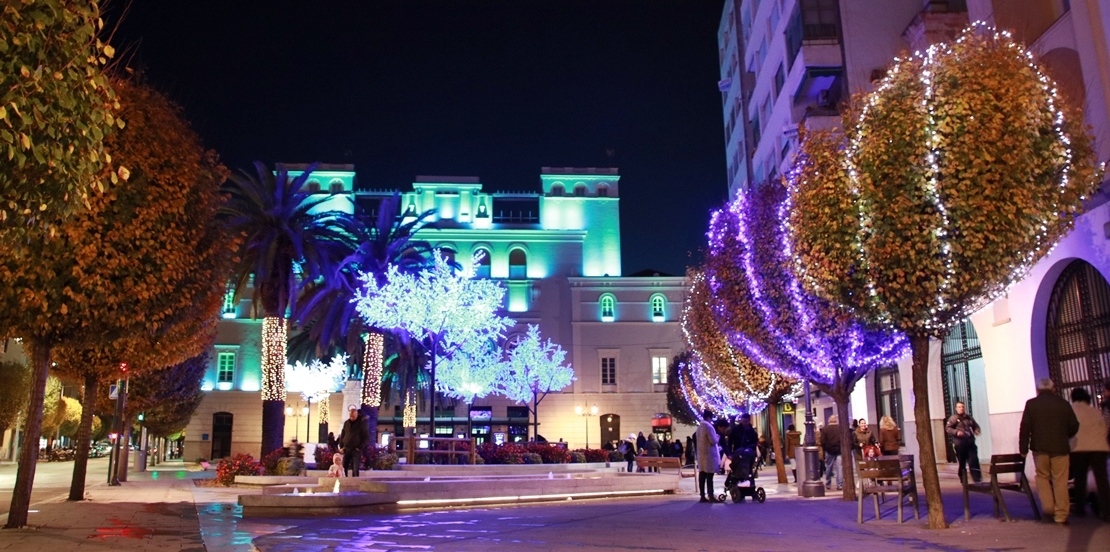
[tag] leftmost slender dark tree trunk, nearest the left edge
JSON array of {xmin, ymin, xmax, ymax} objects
[{"xmin": 4, "ymin": 343, "xmax": 51, "ymax": 529}]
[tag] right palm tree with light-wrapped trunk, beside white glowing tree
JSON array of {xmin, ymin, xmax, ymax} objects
[{"xmin": 295, "ymin": 193, "xmax": 435, "ymax": 440}]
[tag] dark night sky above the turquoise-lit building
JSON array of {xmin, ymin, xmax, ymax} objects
[{"xmin": 105, "ymin": 0, "xmax": 727, "ymax": 274}]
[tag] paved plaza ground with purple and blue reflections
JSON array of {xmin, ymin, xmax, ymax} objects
[{"xmin": 0, "ymin": 463, "xmax": 1110, "ymax": 552}]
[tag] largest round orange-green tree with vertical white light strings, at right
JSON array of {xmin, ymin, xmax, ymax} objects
[{"xmin": 789, "ymin": 26, "xmax": 1100, "ymax": 529}]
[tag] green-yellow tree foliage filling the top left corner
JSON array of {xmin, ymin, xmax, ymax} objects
[{"xmin": 0, "ymin": 0, "xmax": 123, "ymax": 227}]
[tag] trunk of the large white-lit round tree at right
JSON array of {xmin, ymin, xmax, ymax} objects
[{"xmin": 909, "ymin": 335, "xmax": 948, "ymax": 529}]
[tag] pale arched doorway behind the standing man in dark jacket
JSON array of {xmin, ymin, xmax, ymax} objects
[{"xmin": 940, "ymin": 319, "xmax": 990, "ymax": 462}]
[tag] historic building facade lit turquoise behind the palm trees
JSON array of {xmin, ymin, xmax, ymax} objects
[{"xmin": 185, "ymin": 165, "xmax": 693, "ymax": 460}]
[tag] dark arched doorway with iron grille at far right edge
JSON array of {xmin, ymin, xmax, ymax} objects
[{"xmin": 1045, "ymin": 260, "xmax": 1110, "ymax": 398}]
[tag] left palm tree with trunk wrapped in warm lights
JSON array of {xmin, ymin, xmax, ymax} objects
[{"xmin": 221, "ymin": 161, "xmax": 354, "ymax": 455}]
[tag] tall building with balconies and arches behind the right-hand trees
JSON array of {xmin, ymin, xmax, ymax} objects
[{"xmin": 718, "ymin": 0, "xmax": 1110, "ymax": 469}]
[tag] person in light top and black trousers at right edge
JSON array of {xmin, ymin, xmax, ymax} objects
[{"xmin": 1070, "ymin": 388, "xmax": 1110, "ymax": 521}]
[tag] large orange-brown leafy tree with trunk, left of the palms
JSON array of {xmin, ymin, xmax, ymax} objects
[{"xmin": 46, "ymin": 81, "xmax": 236, "ymax": 500}]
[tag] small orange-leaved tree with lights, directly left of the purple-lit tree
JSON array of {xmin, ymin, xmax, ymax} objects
[{"xmin": 682, "ymin": 270, "xmax": 798, "ymax": 483}]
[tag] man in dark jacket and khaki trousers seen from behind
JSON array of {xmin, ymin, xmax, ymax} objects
[{"xmin": 1018, "ymin": 378, "xmax": 1079, "ymax": 525}]
